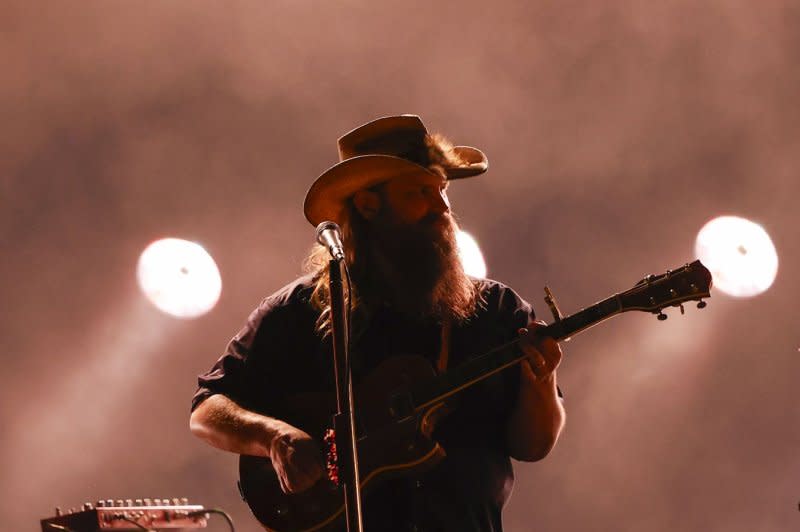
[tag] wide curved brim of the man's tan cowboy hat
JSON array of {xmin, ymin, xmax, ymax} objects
[{"xmin": 303, "ymin": 146, "xmax": 489, "ymax": 226}]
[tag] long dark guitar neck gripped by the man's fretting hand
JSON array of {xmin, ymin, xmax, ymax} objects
[{"xmin": 411, "ymin": 294, "xmax": 623, "ymax": 410}]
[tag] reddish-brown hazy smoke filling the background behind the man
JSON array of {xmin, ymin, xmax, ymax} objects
[{"xmin": 0, "ymin": 0, "xmax": 800, "ymax": 532}]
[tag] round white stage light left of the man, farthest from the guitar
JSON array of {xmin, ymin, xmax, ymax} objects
[{"xmin": 136, "ymin": 238, "xmax": 222, "ymax": 318}]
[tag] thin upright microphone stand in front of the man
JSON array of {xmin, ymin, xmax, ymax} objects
[{"xmin": 328, "ymin": 257, "xmax": 363, "ymax": 532}]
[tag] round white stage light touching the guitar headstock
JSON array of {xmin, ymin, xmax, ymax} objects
[{"xmin": 695, "ymin": 216, "xmax": 778, "ymax": 297}]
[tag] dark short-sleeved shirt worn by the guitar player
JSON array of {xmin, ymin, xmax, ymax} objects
[{"xmin": 192, "ymin": 277, "xmax": 534, "ymax": 532}]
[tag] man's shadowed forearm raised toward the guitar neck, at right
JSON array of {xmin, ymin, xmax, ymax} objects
[{"xmin": 507, "ymin": 361, "xmax": 566, "ymax": 461}]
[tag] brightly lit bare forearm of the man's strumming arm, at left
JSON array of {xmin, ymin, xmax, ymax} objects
[{"xmin": 189, "ymin": 394, "xmax": 285, "ymax": 457}]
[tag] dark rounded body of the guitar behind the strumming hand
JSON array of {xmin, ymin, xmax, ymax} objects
[{"xmin": 239, "ymin": 356, "xmax": 448, "ymax": 532}]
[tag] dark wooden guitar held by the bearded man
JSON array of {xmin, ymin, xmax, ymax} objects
[{"xmin": 234, "ymin": 261, "xmax": 711, "ymax": 532}]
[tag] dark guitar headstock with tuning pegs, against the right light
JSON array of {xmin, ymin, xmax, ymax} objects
[{"xmin": 618, "ymin": 260, "xmax": 711, "ymax": 320}]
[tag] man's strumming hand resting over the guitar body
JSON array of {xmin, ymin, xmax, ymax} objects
[{"xmin": 269, "ymin": 423, "xmax": 325, "ymax": 493}]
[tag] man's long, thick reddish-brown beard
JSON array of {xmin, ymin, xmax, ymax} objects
[{"xmin": 359, "ymin": 215, "xmax": 477, "ymax": 322}]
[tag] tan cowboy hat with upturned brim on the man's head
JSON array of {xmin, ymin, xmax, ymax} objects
[{"xmin": 303, "ymin": 115, "xmax": 489, "ymax": 226}]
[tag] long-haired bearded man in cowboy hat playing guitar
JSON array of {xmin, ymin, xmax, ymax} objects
[{"xmin": 190, "ymin": 115, "xmax": 565, "ymax": 532}]
